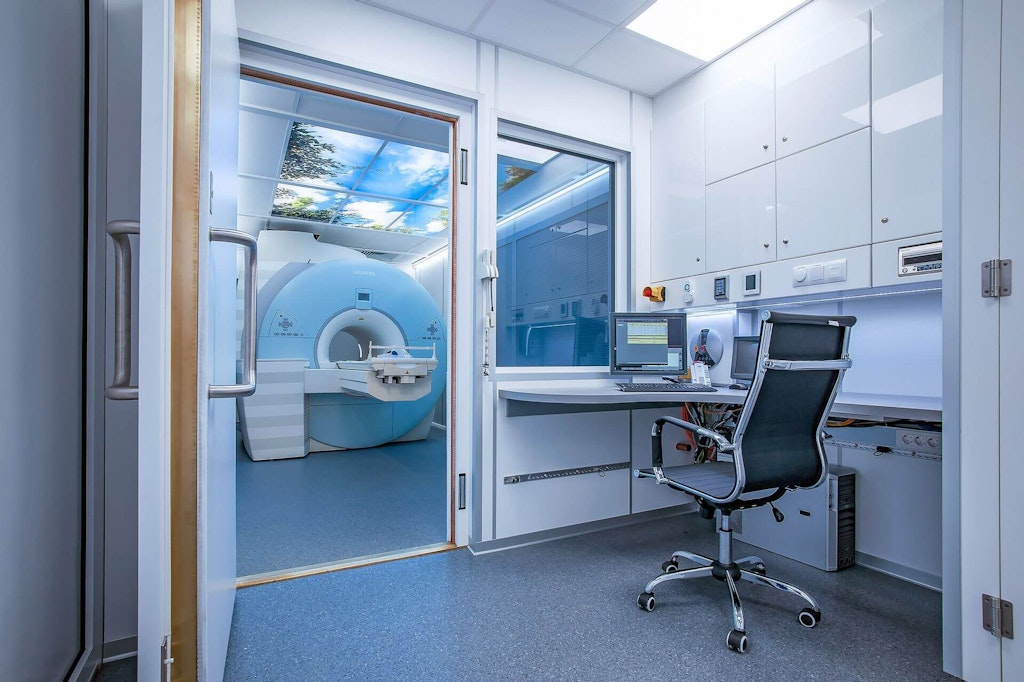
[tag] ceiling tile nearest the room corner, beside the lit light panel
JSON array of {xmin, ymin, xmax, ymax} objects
[{"xmin": 574, "ymin": 29, "xmax": 705, "ymax": 97}]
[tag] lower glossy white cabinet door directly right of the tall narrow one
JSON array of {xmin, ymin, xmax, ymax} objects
[{"xmin": 706, "ymin": 164, "xmax": 775, "ymax": 271}]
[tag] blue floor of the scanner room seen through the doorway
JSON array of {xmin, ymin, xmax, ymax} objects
[{"xmin": 237, "ymin": 428, "xmax": 449, "ymax": 576}]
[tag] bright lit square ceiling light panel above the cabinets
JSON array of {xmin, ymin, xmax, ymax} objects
[{"xmin": 626, "ymin": 0, "xmax": 807, "ymax": 61}]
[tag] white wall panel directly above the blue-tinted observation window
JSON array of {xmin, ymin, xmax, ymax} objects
[{"xmin": 495, "ymin": 50, "xmax": 630, "ymax": 150}]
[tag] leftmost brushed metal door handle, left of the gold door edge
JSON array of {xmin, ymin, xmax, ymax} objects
[{"xmin": 103, "ymin": 220, "xmax": 138, "ymax": 400}]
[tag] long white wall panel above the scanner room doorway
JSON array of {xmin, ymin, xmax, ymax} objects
[{"xmin": 238, "ymin": 0, "xmax": 476, "ymax": 91}]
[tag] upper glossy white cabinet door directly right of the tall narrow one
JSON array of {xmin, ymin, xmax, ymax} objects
[{"xmin": 705, "ymin": 69, "xmax": 775, "ymax": 182}]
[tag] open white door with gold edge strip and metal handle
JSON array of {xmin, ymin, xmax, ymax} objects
[{"xmin": 138, "ymin": 0, "xmax": 240, "ymax": 680}]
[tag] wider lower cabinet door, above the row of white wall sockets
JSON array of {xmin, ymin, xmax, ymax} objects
[{"xmin": 775, "ymin": 129, "xmax": 871, "ymax": 260}]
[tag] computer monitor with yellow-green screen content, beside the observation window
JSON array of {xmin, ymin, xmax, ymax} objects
[{"xmin": 608, "ymin": 312, "xmax": 686, "ymax": 375}]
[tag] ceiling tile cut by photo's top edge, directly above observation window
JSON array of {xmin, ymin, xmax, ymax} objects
[{"xmin": 473, "ymin": 0, "xmax": 612, "ymax": 66}]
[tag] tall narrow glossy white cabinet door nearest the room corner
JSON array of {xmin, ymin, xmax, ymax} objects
[{"xmin": 650, "ymin": 103, "xmax": 705, "ymax": 282}]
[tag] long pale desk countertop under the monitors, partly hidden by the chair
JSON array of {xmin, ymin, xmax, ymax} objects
[{"xmin": 498, "ymin": 382, "xmax": 942, "ymax": 422}]
